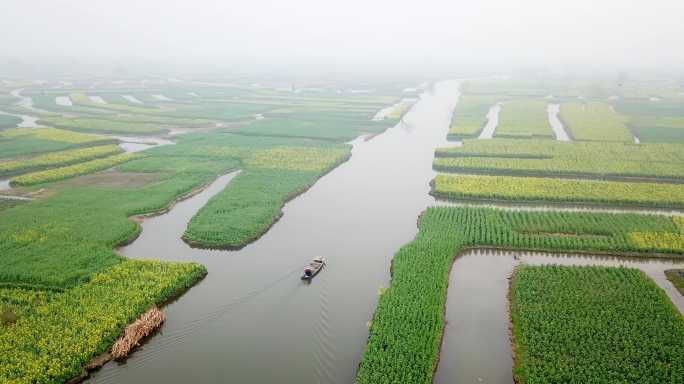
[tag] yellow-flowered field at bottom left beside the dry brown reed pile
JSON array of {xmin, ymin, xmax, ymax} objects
[{"xmin": 0, "ymin": 261, "xmax": 206, "ymax": 384}]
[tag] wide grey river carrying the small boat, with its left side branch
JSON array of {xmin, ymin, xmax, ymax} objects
[{"xmin": 91, "ymin": 81, "xmax": 458, "ymax": 384}]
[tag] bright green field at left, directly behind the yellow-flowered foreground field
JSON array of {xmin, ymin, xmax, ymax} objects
[{"xmin": 0, "ymin": 163, "xmax": 237, "ymax": 290}]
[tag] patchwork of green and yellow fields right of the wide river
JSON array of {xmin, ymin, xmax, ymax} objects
[{"xmin": 357, "ymin": 79, "xmax": 684, "ymax": 383}]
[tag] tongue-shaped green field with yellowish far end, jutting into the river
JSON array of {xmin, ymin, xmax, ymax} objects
[{"xmin": 183, "ymin": 146, "xmax": 349, "ymax": 248}]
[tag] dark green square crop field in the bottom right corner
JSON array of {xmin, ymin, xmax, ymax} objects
[{"xmin": 511, "ymin": 266, "xmax": 684, "ymax": 383}]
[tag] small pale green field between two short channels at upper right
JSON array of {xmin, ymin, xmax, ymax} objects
[{"xmin": 494, "ymin": 100, "xmax": 554, "ymax": 139}]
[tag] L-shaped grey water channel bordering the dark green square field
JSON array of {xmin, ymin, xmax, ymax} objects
[{"xmin": 434, "ymin": 250, "xmax": 684, "ymax": 384}]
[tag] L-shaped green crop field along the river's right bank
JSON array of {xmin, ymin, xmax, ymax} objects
[{"xmin": 357, "ymin": 207, "xmax": 684, "ymax": 383}]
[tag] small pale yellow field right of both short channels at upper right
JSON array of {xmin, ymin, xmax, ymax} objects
[{"xmin": 559, "ymin": 102, "xmax": 634, "ymax": 143}]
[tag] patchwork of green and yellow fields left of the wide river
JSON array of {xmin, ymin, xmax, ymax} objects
[{"xmin": 0, "ymin": 76, "xmax": 408, "ymax": 383}]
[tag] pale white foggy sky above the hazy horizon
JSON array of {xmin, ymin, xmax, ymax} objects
[{"xmin": 0, "ymin": 0, "xmax": 684, "ymax": 76}]
